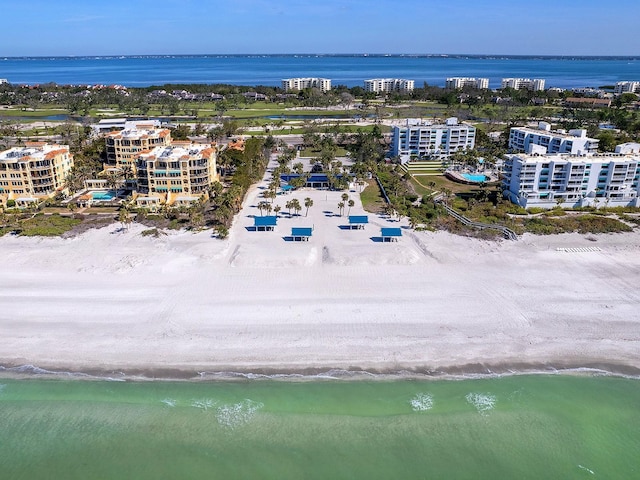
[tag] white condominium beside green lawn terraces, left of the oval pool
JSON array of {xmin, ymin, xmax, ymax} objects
[{"xmin": 391, "ymin": 118, "xmax": 476, "ymax": 161}]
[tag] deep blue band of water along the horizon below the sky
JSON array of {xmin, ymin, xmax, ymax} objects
[{"xmin": 0, "ymin": 55, "xmax": 640, "ymax": 88}]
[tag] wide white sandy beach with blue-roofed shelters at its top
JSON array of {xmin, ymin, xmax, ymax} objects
[{"xmin": 0, "ymin": 163, "xmax": 640, "ymax": 375}]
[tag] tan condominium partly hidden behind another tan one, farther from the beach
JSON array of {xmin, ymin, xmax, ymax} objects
[{"xmin": 105, "ymin": 123, "xmax": 171, "ymax": 169}]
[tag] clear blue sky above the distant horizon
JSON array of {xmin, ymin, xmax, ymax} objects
[{"xmin": 0, "ymin": 0, "xmax": 640, "ymax": 56}]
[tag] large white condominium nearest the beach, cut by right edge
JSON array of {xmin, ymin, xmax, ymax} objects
[{"xmin": 503, "ymin": 153, "xmax": 640, "ymax": 208}]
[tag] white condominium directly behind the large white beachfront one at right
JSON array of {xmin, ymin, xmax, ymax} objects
[{"xmin": 509, "ymin": 122, "xmax": 599, "ymax": 155}]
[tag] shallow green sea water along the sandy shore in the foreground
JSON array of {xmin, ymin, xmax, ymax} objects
[{"xmin": 0, "ymin": 375, "xmax": 640, "ymax": 480}]
